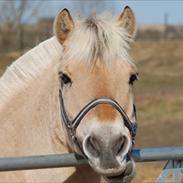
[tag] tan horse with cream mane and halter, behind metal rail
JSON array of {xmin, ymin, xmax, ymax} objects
[{"xmin": 0, "ymin": 6, "xmax": 138, "ymax": 183}]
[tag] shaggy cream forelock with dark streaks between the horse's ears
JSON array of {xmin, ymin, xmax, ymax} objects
[{"xmin": 63, "ymin": 15, "xmax": 132, "ymax": 65}]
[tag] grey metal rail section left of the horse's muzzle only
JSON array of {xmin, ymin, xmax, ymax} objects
[{"xmin": 0, "ymin": 153, "xmax": 87, "ymax": 172}]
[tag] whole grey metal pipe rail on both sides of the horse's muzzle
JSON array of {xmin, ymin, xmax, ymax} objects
[{"xmin": 0, "ymin": 147, "xmax": 183, "ymax": 171}]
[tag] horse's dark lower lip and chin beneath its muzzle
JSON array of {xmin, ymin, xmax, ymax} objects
[{"xmin": 104, "ymin": 160, "xmax": 136, "ymax": 183}]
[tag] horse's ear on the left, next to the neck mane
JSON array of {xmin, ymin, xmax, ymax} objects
[{"xmin": 54, "ymin": 8, "xmax": 74, "ymax": 44}]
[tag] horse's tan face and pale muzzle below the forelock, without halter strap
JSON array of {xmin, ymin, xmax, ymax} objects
[{"xmin": 62, "ymin": 61, "xmax": 137, "ymax": 182}]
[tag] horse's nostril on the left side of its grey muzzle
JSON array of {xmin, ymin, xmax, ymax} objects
[{"xmin": 84, "ymin": 136, "xmax": 100, "ymax": 158}]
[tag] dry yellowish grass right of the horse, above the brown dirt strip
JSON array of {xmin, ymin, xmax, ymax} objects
[{"xmin": 132, "ymin": 41, "xmax": 183, "ymax": 124}]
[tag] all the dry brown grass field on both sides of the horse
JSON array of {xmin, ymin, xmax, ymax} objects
[{"xmin": 0, "ymin": 40, "xmax": 183, "ymax": 183}]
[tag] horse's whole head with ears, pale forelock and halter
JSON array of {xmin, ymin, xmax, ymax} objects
[{"xmin": 54, "ymin": 7, "xmax": 138, "ymax": 182}]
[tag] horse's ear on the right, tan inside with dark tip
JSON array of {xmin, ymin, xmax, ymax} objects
[{"xmin": 119, "ymin": 6, "xmax": 136, "ymax": 38}]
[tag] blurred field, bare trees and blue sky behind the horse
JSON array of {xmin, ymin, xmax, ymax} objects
[{"xmin": 0, "ymin": 0, "xmax": 183, "ymax": 183}]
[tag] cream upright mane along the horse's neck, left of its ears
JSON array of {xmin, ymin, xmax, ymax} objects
[{"xmin": 0, "ymin": 37, "xmax": 62, "ymax": 107}]
